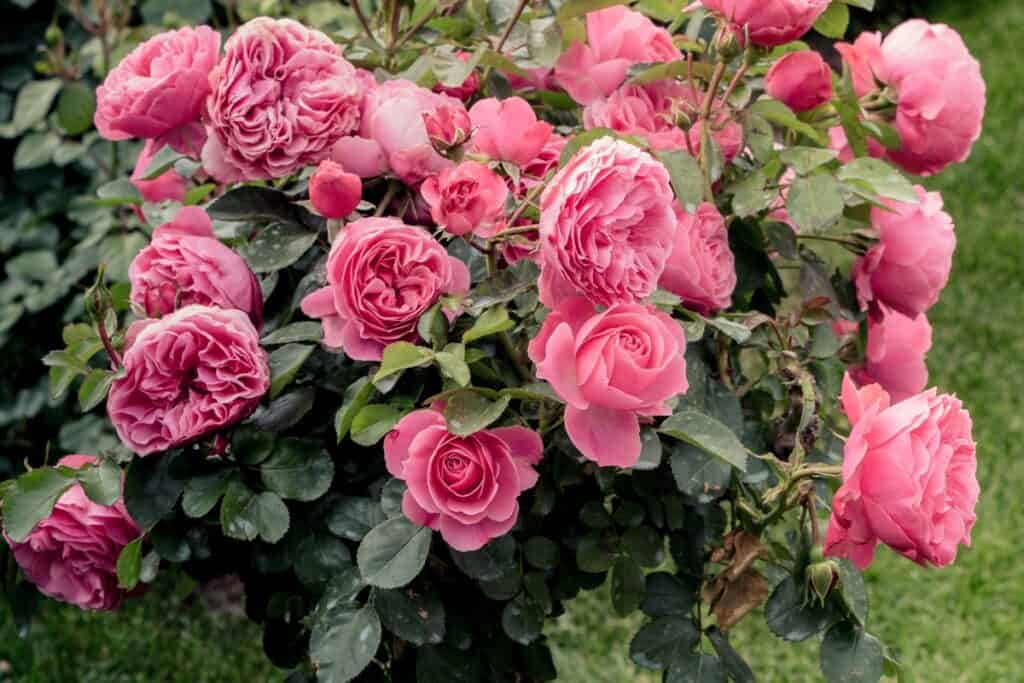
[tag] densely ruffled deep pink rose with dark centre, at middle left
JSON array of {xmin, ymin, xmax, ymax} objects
[{"xmin": 106, "ymin": 305, "xmax": 270, "ymax": 456}]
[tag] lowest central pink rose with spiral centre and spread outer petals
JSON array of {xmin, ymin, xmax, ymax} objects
[{"xmin": 384, "ymin": 410, "xmax": 544, "ymax": 552}]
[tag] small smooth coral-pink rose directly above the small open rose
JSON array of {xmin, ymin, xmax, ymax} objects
[{"xmin": 469, "ymin": 97, "xmax": 552, "ymax": 166}]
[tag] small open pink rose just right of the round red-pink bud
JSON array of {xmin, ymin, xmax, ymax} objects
[{"xmin": 420, "ymin": 161, "xmax": 509, "ymax": 237}]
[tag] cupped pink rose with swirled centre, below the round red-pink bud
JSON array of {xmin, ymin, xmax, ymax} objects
[{"xmin": 302, "ymin": 218, "xmax": 469, "ymax": 360}]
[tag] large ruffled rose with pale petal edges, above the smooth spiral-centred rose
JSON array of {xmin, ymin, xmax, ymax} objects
[{"xmin": 540, "ymin": 137, "xmax": 676, "ymax": 308}]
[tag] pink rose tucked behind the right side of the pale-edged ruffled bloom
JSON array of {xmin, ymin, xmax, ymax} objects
[{"xmin": 658, "ymin": 202, "xmax": 736, "ymax": 315}]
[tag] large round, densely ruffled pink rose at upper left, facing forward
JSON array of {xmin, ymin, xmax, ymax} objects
[{"xmin": 203, "ymin": 16, "xmax": 364, "ymax": 182}]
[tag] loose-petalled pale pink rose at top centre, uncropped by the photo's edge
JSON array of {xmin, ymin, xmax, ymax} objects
[{"xmin": 555, "ymin": 5, "xmax": 683, "ymax": 104}]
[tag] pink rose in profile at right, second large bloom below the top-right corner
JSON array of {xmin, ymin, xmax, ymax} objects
[{"xmin": 853, "ymin": 185, "xmax": 956, "ymax": 317}]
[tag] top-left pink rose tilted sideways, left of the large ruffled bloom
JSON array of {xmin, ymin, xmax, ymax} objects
[{"xmin": 93, "ymin": 26, "xmax": 220, "ymax": 145}]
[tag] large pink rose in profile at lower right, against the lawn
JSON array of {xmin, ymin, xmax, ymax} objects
[{"xmin": 824, "ymin": 376, "xmax": 979, "ymax": 569}]
